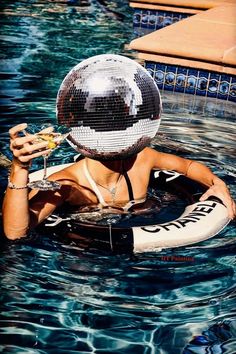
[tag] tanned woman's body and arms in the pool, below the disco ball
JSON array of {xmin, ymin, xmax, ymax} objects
[{"xmin": 3, "ymin": 123, "xmax": 236, "ymax": 240}]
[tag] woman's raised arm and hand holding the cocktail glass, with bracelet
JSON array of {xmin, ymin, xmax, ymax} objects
[{"xmin": 3, "ymin": 123, "xmax": 50, "ymax": 240}]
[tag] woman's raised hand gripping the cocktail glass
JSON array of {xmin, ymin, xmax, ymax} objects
[{"xmin": 9, "ymin": 123, "xmax": 50, "ymax": 167}]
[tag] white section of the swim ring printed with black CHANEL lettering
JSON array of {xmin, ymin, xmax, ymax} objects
[{"xmin": 132, "ymin": 200, "xmax": 229, "ymax": 252}]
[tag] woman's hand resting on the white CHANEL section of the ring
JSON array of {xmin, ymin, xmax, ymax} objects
[{"xmin": 200, "ymin": 178, "xmax": 236, "ymax": 219}]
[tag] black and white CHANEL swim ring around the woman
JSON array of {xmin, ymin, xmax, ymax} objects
[{"xmin": 30, "ymin": 164, "xmax": 230, "ymax": 252}]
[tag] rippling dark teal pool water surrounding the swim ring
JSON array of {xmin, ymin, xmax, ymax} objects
[{"xmin": 0, "ymin": 0, "xmax": 236, "ymax": 354}]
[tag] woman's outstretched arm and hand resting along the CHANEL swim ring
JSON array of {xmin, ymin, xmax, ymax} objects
[{"xmin": 148, "ymin": 149, "xmax": 236, "ymax": 219}]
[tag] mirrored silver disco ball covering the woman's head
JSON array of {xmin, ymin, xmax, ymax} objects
[{"xmin": 57, "ymin": 54, "xmax": 161, "ymax": 160}]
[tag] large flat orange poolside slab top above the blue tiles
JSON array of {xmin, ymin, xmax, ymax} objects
[{"xmin": 130, "ymin": 5, "xmax": 236, "ymax": 66}]
